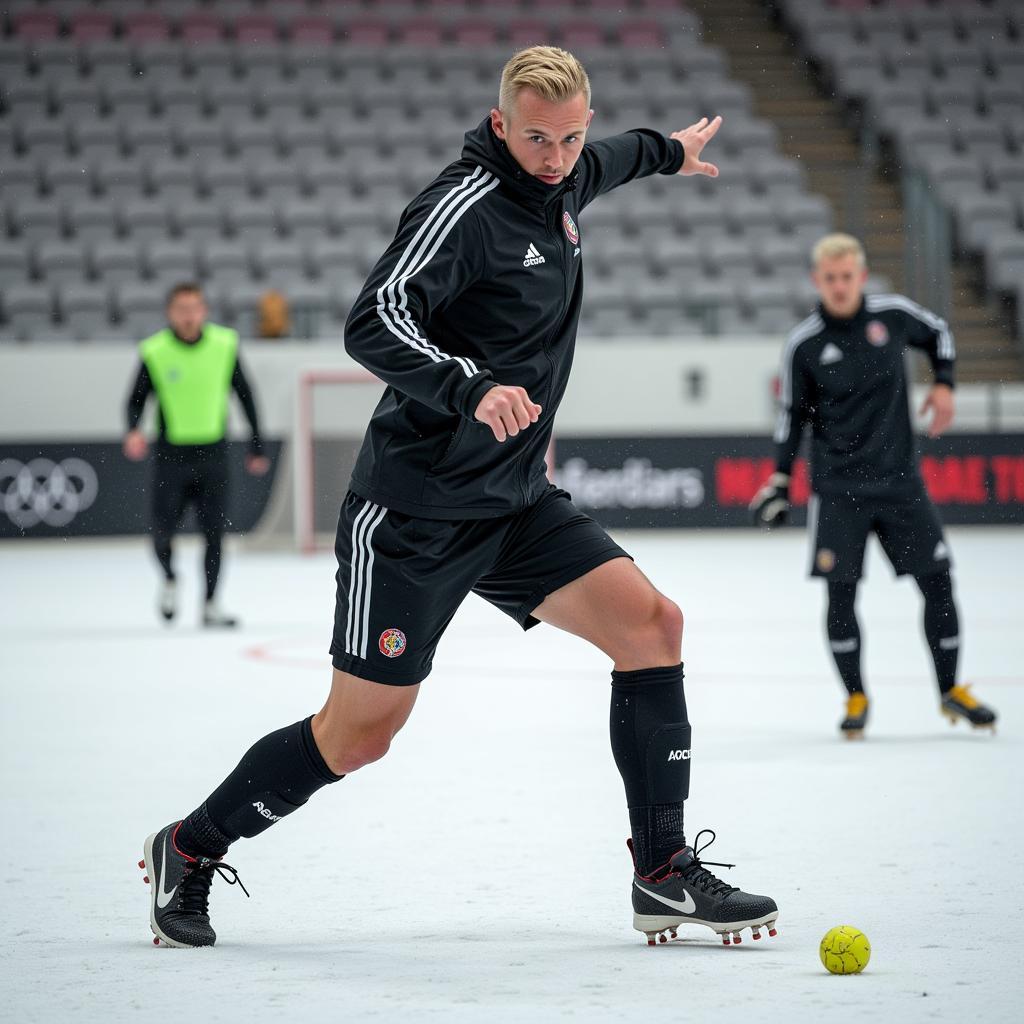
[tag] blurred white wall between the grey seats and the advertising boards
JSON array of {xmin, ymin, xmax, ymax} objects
[{"xmin": 0, "ymin": 338, "xmax": 1024, "ymax": 441}]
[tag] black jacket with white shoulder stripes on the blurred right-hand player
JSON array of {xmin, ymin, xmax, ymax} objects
[{"xmin": 775, "ymin": 295, "xmax": 955, "ymax": 498}]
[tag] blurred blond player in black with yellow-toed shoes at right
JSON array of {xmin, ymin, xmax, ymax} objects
[{"xmin": 751, "ymin": 234, "xmax": 995, "ymax": 738}]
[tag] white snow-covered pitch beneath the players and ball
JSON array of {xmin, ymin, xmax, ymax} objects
[{"xmin": 0, "ymin": 529, "xmax": 1024, "ymax": 1024}]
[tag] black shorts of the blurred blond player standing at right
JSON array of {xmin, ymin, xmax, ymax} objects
[{"xmin": 807, "ymin": 484, "xmax": 951, "ymax": 583}]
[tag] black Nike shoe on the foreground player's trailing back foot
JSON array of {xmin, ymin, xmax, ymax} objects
[{"xmin": 138, "ymin": 821, "xmax": 249, "ymax": 949}]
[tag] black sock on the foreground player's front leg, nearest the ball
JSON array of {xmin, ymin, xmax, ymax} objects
[{"xmin": 610, "ymin": 665, "xmax": 690, "ymax": 876}]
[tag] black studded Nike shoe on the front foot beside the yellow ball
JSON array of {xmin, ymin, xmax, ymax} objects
[{"xmin": 628, "ymin": 828, "xmax": 778, "ymax": 946}]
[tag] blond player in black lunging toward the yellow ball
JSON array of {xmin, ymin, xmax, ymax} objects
[{"xmin": 140, "ymin": 46, "xmax": 778, "ymax": 946}]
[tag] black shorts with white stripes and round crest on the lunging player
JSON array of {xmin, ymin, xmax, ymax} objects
[{"xmin": 331, "ymin": 486, "xmax": 630, "ymax": 686}]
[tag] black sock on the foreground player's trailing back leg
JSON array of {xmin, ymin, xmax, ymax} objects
[{"xmin": 177, "ymin": 718, "xmax": 342, "ymax": 857}]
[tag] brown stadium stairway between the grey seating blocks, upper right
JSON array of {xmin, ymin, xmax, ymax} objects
[{"xmin": 700, "ymin": 0, "xmax": 1024, "ymax": 381}]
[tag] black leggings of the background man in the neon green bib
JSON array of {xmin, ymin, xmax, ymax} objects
[{"xmin": 153, "ymin": 444, "xmax": 227, "ymax": 601}]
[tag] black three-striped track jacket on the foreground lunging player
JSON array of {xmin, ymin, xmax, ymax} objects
[{"xmin": 345, "ymin": 118, "xmax": 683, "ymax": 519}]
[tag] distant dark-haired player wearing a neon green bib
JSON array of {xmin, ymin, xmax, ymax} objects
[{"xmin": 123, "ymin": 282, "xmax": 270, "ymax": 627}]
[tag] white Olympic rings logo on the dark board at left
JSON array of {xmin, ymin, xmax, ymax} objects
[{"xmin": 0, "ymin": 459, "xmax": 99, "ymax": 529}]
